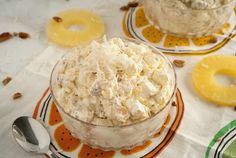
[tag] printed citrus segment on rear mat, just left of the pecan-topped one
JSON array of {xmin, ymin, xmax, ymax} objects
[{"xmin": 164, "ymin": 35, "xmax": 189, "ymax": 48}]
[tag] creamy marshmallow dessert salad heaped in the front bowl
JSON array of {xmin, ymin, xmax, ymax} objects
[{"xmin": 54, "ymin": 38, "xmax": 174, "ymax": 126}]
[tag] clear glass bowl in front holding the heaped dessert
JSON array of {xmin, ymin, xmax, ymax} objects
[{"xmin": 50, "ymin": 39, "xmax": 176, "ymax": 150}]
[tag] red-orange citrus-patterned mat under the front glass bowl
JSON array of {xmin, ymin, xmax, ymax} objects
[{"xmin": 33, "ymin": 89, "xmax": 184, "ymax": 158}]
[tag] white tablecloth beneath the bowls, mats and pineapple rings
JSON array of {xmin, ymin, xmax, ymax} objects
[{"xmin": 0, "ymin": 0, "xmax": 236, "ymax": 158}]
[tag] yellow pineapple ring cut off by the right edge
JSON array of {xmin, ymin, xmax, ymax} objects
[{"xmin": 192, "ymin": 55, "xmax": 236, "ymax": 106}]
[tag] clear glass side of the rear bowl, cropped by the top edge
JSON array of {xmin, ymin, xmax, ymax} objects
[{"xmin": 143, "ymin": 0, "xmax": 235, "ymax": 37}]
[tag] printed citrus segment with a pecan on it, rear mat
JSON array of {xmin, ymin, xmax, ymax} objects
[{"xmin": 192, "ymin": 35, "xmax": 217, "ymax": 46}]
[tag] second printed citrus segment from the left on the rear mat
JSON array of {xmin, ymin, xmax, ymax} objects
[{"xmin": 142, "ymin": 26, "xmax": 164, "ymax": 43}]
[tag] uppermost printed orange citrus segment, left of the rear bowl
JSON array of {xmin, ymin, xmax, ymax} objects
[{"xmin": 135, "ymin": 7, "xmax": 149, "ymax": 28}]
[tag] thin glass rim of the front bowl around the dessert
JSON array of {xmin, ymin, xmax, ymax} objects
[{"xmin": 49, "ymin": 37, "xmax": 177, "ymax": 128}]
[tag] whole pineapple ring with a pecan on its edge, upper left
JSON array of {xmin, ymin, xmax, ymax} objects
[{"xmin": 47, "ymin": 10, "xmax": 105, "ymax": 47}]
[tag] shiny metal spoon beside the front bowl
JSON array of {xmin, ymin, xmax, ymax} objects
[{"xmin": 12, "ymin": 116, "xmax": 58, "ymax": 158}]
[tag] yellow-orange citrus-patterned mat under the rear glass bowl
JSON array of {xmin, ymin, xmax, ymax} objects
[{"xmin": 123, "ymin": 6, "xmax": 236, "ymax": 55}]
